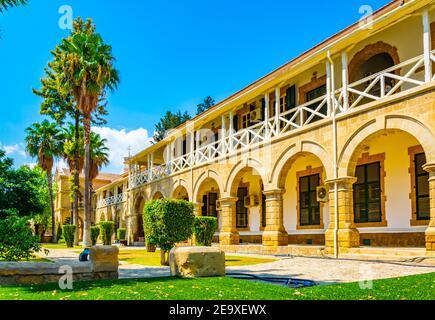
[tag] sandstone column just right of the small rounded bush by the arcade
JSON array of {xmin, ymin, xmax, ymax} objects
[{"xmin": 219, "ymin": 197, "xmax": 240, "ymax": 245}]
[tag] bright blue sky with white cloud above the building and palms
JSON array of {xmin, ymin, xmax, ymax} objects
[{"xmin": 0, "ymin": 0, "xmax": 388, "ymax": 172}]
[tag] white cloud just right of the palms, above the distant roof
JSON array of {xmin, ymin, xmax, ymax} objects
[{"xmin": 92, "ymin": 127, "xmax": 152, "ymax": 172}]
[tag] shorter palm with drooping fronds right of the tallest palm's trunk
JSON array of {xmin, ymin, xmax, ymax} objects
[{"xmin": 89, "ymin": 132, "xmax": 109, "ymax": 214}]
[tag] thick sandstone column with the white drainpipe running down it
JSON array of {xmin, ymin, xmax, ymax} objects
[{"xmin": 325, "ymin": 177, "xmax": 360, "ymax": 253}]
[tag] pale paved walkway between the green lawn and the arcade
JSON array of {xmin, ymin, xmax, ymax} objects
[{"xmin": 38, "ymin": 249, "xmax": 435, "ymax": 284}]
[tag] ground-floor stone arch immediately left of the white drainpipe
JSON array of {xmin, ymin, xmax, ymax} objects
[{"xmin": 269, "ymin": 141, "xmax": 334, "ymax": 189}]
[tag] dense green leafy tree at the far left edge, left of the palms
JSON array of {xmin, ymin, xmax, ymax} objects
[{"xmin": 0, "ymin": 149, "xmax": 50, "ymax": 219}]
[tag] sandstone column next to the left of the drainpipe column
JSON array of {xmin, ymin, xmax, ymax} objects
[{"xmin": 263, "ymin": 189, "xmax": 288, "ymax": 247}]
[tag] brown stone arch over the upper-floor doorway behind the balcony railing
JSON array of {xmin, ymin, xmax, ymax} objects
[{"xmin": 348, "ymin": 41, "xmax": 400, "ymax": 83}]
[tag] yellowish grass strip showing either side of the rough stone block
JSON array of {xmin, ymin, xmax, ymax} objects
[{"xmin": 119, "ymin": 249, "xmax": 276, "ymax": 267}]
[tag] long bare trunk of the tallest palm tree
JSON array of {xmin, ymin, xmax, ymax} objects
[{"xmin": 83, "ymin": 114, "xmax": 92, "ymax": 247}]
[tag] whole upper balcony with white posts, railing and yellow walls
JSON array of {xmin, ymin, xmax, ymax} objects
[{"xmin": 129, "ymin": 1, "xmax": 435, "ymax": 188}]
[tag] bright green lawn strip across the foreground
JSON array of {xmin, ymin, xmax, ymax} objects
[{"xmin": 0, "ymin": 273, "xmax": 435, "ymax": 300}]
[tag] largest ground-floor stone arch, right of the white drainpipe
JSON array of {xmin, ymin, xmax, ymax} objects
[{"xmin": 338, "ymin": 115, "xmax": 435, "ymax": 177}]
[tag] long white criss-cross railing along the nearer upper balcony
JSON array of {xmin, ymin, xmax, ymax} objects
[{"xmin": 129, "ymin": 50, "xmax": 435, "ymax": 188}]
